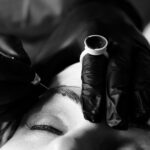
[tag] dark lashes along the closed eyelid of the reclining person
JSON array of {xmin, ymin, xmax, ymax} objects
[{"xmin": 27, "ymin": 124, "xmax": 63, "ymax": 136}]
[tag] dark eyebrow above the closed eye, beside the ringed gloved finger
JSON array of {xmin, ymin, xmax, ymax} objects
[{"xmin": 41, "ymin": 86, "xmax": 81, "ymax": 104}]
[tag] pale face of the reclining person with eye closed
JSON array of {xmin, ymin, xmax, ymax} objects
[{"xmin": 2, "ymin": 64, "xmax": 150, "ymax": 150}]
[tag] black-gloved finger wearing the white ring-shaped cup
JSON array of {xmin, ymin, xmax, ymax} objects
[{"xmin": 81, "ymin": 35, "xmax": 108, "ymax": 122}]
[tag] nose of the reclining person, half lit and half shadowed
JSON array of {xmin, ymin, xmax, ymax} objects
[{"xmin": 44, "ymin": 122, "xmax": 100, "ymax": 150}]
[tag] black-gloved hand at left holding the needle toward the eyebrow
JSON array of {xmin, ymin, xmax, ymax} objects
[{"xmin": 0, "ymin": 35, "xmax": 46, "ymax": 123}]
